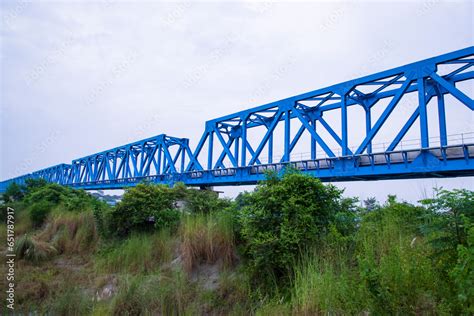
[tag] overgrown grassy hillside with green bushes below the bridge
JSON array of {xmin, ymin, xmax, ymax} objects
[{"xmin": 0, "ymin": 177, "xmax": 474, "ymax": 315}]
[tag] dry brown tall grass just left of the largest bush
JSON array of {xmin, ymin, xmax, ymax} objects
[{"xmin": 180, "ymin": 213, "xmax": 236, "ymax": 272}]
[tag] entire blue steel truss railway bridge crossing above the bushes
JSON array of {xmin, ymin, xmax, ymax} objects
[{"xmin": 0, "ymin": 46, "xmax": 474, "ymax": 191}]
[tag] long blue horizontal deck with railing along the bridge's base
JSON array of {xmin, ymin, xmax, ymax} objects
[{"xmin": 65, "ymin": 143, "xmax": 474, "ymax": 189}]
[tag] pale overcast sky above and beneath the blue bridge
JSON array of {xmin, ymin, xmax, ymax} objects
[{"xmin": 0, "ymin": 0, "xmax": 474, "ymax": 201}]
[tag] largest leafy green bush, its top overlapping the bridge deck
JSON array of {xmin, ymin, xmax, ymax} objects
[{"xmin": 241, "ymin": 172, "xmax": 342, "ymax": 288}]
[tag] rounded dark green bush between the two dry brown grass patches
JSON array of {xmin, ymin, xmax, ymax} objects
[{"xmin": 109, "ymin": 183, "xmax": 180, "ymax": 236}]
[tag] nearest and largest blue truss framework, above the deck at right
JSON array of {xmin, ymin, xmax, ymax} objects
[{"xmin": 186, "ymin": 47, "xmax": 474, "ymax": 171}]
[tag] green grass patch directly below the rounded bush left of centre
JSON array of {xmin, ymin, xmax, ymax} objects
[{"xmin": 96, "ymin": 230, "xmax": 175, "ymax": 274}]
